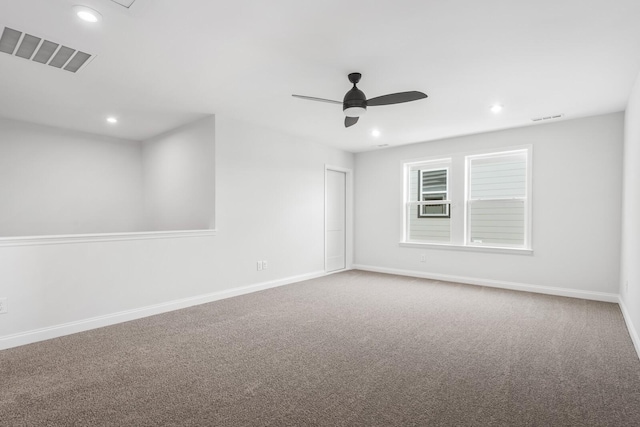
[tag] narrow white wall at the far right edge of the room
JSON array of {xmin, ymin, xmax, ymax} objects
[{"xmin": 620, "ymin": 71, "xmax": 640, "ymax": 354}]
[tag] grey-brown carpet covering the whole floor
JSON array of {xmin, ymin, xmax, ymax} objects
[{"xmin": 0, "ymin": 271, "xmax": 640, "ymax": 426}]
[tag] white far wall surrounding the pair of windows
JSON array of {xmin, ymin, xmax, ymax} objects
[{"xmin": 355, "ymin": 113, "xmax": 624, "ymax": 298}]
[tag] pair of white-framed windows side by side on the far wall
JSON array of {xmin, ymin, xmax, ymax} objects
[{"xmin": 403, "ymin": 147, "xmax": 531, "ymax": 249}]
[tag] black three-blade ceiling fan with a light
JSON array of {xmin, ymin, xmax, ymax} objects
[{"xmin": 292, "ymin": 73, "xmax": 427, "ymax": 128}]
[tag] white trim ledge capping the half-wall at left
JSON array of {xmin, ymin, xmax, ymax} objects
[{"xmin": 0, "ymin": 230, "xmax": 216, "ymax": 247}]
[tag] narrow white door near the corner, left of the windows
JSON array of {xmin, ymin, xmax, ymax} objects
[{"xmin": 325, "ymin": 169, "xmax": 347, "ymax": 271}]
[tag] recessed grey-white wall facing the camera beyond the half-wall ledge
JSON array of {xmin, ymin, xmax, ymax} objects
[{"xmin": 0, "ymin": 119, "xmax": 143, "ymax": 237}]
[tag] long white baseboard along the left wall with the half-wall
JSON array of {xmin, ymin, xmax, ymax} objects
[{"xmin": 0, "ymin": 271, "xmax": 327, "ymax": 350}]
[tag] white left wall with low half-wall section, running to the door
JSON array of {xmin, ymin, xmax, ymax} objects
[{"xmin": 0, "ymin": 116, "xmax": 353, "ymax": 348}]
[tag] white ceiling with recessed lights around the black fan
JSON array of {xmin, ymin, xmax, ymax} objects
[{"xmin": 0, "ymin": 0, "xmax": 640, "ymax": 152}]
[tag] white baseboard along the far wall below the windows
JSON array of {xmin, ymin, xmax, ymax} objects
[{"xmin": 353, "ymin": 264, "xmax": 618, "ymax": 303}]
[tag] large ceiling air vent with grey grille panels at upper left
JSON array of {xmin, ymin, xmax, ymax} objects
[{"xmin": 0, "ymin": 27, "xmax": 93, "ymax": 73}]
